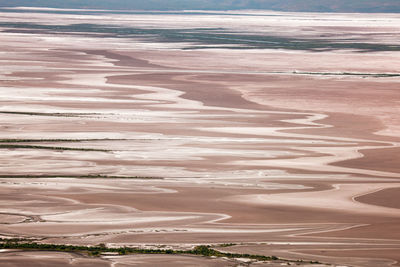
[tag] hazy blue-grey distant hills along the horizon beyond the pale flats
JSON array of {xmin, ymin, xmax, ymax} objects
[{"xmin": 0, "ymin": 0, "xmax": 400, "ymax": 13}]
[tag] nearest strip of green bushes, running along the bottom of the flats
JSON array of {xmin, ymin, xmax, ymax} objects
[{"xmin": 0, "ymin": 243, "xmax": 318, "ymax": 264}]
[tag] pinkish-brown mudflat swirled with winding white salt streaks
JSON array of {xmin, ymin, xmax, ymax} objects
[{"xmin": 0, "ymin": 9, "xmax": 400, "ymax": 267}]
